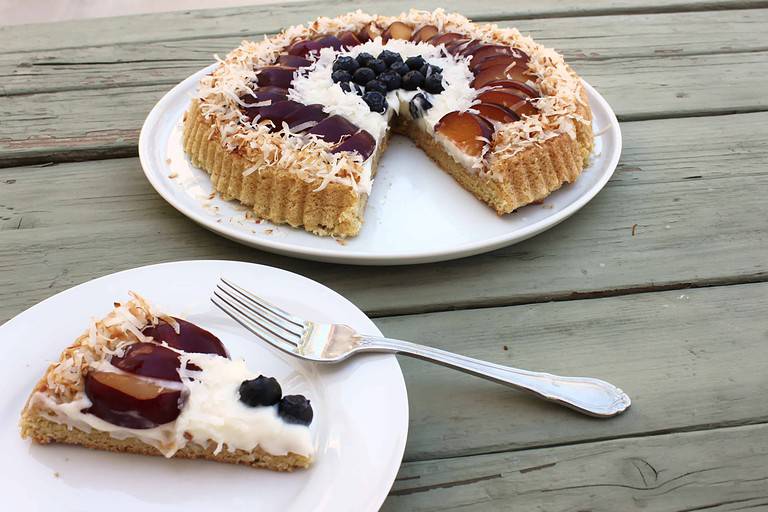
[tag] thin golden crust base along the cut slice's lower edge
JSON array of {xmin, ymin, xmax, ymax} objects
[{"xmin": 21, "ymin": 410, "xmax": 311, "ymax": 472}]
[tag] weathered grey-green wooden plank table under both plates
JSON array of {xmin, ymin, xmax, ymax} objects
[{"xmin": 0, "ymin": 0, "xmax": 768, "ymax": 511}]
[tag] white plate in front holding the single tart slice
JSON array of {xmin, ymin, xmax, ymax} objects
[{"xmin": 0, "ymin": 261, "xmax": 408, "ymax": 512}]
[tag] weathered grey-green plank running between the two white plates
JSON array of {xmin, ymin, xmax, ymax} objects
[{"xmin": 0, "ymin": 113, "xmax": 768, "ymax": 319}]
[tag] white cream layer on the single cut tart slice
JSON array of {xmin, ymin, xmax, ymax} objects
[{"xmin": 33, "ymin": 354, "xmax": 314, "ymax": 457}]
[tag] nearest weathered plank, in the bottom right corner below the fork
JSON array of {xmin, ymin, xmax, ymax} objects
[{"xmin": 382, "ymin": 424, "xmax": 768, "ymax": 512}]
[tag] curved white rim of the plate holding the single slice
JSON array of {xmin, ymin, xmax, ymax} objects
[{"xmin": 0, "ymin": 259, "xmax": 410, "ymax": 511}]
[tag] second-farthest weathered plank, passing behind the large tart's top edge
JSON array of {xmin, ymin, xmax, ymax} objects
[{"xmin": 0, "ymin": 9, "xmax": 768, "ymax": 95}]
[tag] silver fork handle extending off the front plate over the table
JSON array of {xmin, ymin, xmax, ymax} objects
[{"xmin": 360, "ymin": 336, "xmax": 631, "ymax": 418}]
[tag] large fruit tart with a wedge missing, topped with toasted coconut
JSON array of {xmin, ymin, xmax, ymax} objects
[{"xmin": 184, "ymin": 9, "xmax": 593, "ymax": 237}]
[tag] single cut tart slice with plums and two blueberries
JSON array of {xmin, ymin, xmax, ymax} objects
[{"xmin": 20, "ymin": 294, "xmax": 314, "ymax": 471}]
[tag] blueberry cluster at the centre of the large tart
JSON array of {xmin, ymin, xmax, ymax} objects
[{"xmin": 331, "ymin": 50, "xmax": 443, "ymax": 114}]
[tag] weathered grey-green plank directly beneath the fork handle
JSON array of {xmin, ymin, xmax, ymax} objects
[{"xmin": 376, "ymin": 283, "xmax": 768, "ymax": 460}]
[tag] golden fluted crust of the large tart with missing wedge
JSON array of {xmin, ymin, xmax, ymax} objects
[{"xmin": 184, "ymin": 90, "xmax": 594, "ymax": 234}]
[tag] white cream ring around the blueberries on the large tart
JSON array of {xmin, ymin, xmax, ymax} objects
[{"xmin": 289, "ymin": 37, "xmax": 477, "ymax": 169}]
